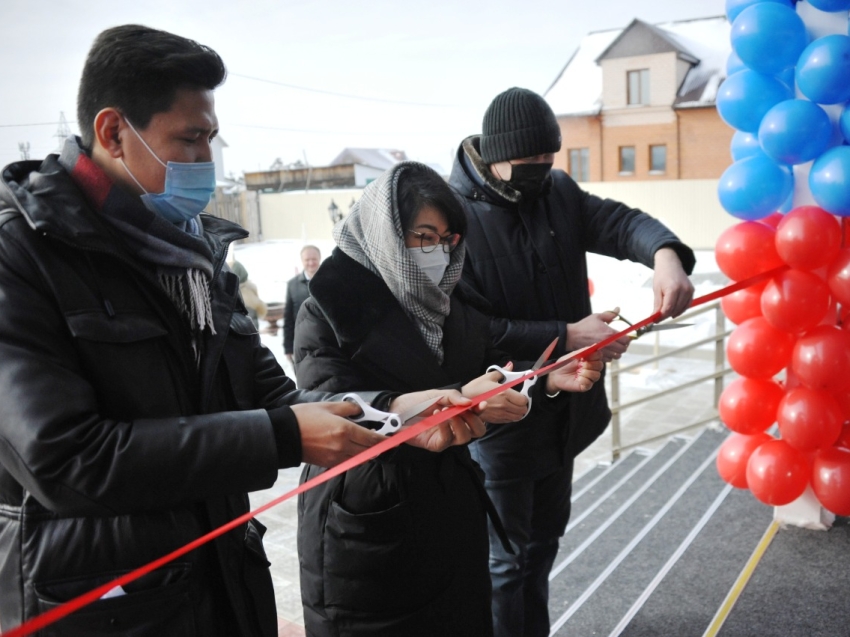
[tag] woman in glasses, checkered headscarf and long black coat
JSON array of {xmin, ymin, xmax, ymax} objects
[{"xmin": 295, "ymin": 162, "xmax": 602, "ymax": 637}]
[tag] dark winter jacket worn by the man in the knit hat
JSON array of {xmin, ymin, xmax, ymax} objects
[{"xmin": 449, "ymin": 137, "xmax": 694, "ymax": 472}]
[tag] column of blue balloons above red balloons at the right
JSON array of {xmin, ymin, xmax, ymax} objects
[{"xmin": 715, "ymin": 0, "xmax": 850, "ymax": 516}]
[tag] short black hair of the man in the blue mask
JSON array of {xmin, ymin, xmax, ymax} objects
[{"xmin": 77, "ymin": 24, "xmax": 227, "ymax": 148}]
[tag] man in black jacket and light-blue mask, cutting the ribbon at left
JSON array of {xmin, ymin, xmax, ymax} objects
[{"xmin": 0, "ymin": 25, "xmax": 483, "ymax": 637}]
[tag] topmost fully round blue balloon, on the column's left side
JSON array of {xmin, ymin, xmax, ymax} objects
[{"xmin": 731, "ymin": 2, "xmax": 809, "ymax": 75}]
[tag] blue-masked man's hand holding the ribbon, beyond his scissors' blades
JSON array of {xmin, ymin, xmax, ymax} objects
[{"xmin": 389, "ymin": 389, "xmax": 487, "ymax": 451}]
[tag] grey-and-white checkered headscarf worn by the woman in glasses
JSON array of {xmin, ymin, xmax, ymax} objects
[{"xmin": 333, "ymin": 161, "xmax": 465, "ymax": 364}]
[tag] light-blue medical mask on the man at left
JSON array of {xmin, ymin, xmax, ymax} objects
[{"xmin": 121, "ymin": 120, "xmax": 215, "ymax": 223}]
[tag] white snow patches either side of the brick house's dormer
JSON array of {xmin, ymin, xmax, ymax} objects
[{"xmin": 545, "ymin": 16, "xmax": 732, "ymax": 115}]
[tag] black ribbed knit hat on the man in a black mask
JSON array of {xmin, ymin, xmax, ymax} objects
[{"xmin": 481, "ymin": 87, "xmax": 561, "ymax": 164}]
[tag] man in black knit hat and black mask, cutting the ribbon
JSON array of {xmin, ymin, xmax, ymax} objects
[{"xmin": 449, "ymin": 88, "xmax": 694, "ymax": 637}]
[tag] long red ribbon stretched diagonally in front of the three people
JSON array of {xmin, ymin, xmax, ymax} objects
[{"xmin": 0, "ymin": 265, "xmax": 788, "ymax": 637}]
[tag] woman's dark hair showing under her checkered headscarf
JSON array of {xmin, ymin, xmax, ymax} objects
[{"xmin": 397, "ymin": 164, "xmax": 466, "ymax": 237}]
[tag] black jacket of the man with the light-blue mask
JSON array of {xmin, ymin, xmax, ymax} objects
[{"xmin": 0, "ymin": 156, "xmax": 374, "ymax": 637}]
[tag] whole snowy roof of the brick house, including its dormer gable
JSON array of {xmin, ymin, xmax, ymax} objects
[{"xmin": 544, "ymin": 16, "xmax": 732, "ymax": 115}]
